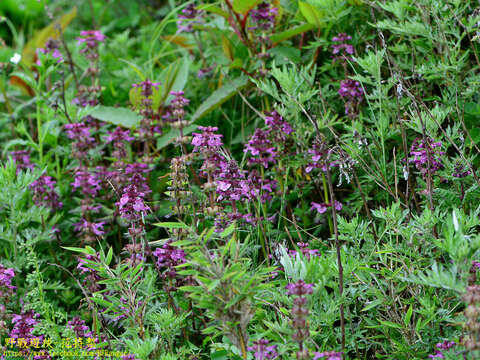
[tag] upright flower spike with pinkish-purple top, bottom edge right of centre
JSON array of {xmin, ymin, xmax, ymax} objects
[{"xmin": 285, "ymin": 280, "xmax": 313, "ymax": 360}]
